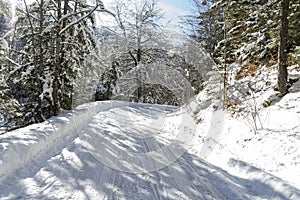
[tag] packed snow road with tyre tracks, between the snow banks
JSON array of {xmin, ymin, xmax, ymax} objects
[{"xmin": 0, "ymin": 104, "xmax": 300, "ymax": 200}]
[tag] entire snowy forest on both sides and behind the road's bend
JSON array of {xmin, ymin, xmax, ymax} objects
[{"xmin": 0, "ymin": 0, "xmax": 300, "ymax": 132}]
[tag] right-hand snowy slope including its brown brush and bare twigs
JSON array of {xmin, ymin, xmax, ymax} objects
[{"xmin": 191, "ymin": 65, "xmax": 300, "ymax": 190}]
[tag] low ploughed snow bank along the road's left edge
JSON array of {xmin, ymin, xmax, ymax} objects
[{"xmin": 0, "ymin": 101, "xmax": 128, "ymax": 179}]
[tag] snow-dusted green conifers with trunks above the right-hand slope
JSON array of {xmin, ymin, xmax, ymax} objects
[{"xmin": 185, "ymin": 0, "xmax": 300, "ymax": 105}]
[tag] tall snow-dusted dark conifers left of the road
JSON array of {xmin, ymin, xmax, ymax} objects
[{"xmin": 1, "ymin": 0, "xmax": 104, "ymax": 130}]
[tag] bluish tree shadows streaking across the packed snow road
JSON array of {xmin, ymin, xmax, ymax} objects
[{"xmin": 0, "ymin": 104, "xmax": 300, "ymax": 200}]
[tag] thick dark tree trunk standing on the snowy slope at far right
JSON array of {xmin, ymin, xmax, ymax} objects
[{"xmin": 277, "ymin": 0, "xmax": 290, "ymax": 94}]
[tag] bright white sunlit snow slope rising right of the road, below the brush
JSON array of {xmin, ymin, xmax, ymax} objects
[{"xmin": 190, "ymin": 93, "xmax": 300, "ymax": 199}]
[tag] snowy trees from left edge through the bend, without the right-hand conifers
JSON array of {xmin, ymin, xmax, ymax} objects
[{"xmin": 0, "ymin": 0, "xmax": 211, "ymax": 131}]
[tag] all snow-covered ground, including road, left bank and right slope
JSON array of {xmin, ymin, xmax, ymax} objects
[{"xmin": 0, "ymin": 65, "xmax": 300, "ymax": 200}]
